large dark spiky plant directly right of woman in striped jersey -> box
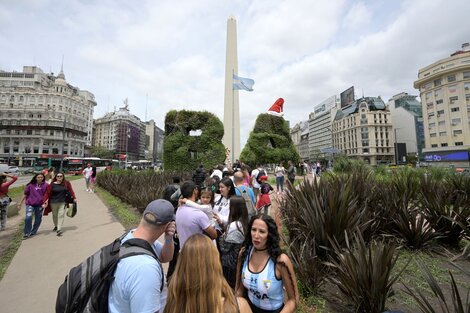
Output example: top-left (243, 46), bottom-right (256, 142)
top-left (280, 175), bottom-right (370, 289)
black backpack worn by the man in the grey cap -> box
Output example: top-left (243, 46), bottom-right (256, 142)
top-left (55, 234), bottom-right (164, 313)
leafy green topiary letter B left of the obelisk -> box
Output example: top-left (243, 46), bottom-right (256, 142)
top-left (163, 110), bottom-right (225, 171)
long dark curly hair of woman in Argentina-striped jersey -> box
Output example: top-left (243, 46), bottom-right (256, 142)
top-left (241, 214), bottom-right (282, 268)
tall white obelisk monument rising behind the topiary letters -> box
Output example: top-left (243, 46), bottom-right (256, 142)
top-left (222, 17), bottom-right (240, 164)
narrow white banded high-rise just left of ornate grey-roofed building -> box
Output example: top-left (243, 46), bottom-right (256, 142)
top-left (308, 96), bottom-right (339, 161)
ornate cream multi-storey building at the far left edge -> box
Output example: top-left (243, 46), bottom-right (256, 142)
top-left (0, 66), bottom-right (96, 166)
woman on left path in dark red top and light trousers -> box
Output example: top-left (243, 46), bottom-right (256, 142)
top-left (42, 172), bottom-right (77, 237)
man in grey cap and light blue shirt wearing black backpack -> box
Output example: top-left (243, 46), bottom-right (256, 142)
top-left (55, 199), bottom-right (176, 313)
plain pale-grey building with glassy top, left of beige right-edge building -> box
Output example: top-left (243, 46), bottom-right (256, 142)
top-left (387, 92), bottom-right (425, 159)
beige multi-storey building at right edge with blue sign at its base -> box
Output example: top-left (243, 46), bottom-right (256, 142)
top-left (414, 43), bottom-right (470, 167)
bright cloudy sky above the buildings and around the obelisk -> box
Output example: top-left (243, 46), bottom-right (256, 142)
top-left (0, 0), bottom-right (470, 147)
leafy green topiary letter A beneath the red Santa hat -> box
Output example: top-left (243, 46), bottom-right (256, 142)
top-left (240, 113), bottom-right (300, 166)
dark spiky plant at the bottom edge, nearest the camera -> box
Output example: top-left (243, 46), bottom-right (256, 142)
top-left (328, 232), bottom-right (405, 313)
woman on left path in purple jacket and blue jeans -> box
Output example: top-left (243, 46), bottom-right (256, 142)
top-left (18, 173), bottom-right (49, 239)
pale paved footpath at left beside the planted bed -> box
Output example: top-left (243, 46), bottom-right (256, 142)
top-left (0, 179), bottom-right (130, 313)
